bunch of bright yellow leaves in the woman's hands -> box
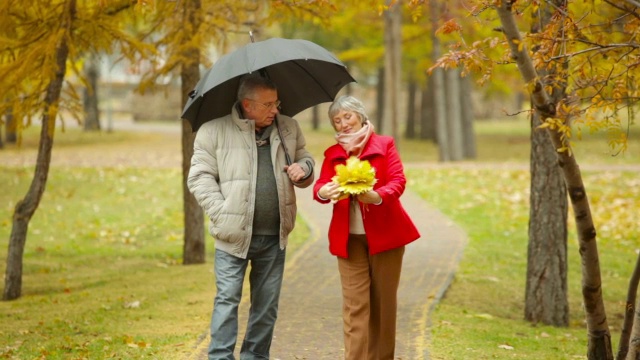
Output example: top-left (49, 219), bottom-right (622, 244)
top-left (331, 156), bottom-right (378, 195)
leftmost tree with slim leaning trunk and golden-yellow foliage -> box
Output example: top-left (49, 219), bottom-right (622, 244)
top-left (0, 0), bottom-right (151, 300)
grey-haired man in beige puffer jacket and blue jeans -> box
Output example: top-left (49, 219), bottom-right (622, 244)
top-left (187, 74), bottom-right (314, 360)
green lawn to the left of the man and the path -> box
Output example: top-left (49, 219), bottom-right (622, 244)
top-left (0, 168), bottom-right (309, 359)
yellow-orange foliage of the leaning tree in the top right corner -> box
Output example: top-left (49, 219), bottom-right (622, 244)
top-left (429, 0), bottom-right (640, 151)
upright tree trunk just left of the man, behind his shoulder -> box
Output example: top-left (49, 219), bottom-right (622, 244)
top-left (180, 0), bottom-right (206, 265)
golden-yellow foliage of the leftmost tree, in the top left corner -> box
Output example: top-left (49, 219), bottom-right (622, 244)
top-left (0, 0), bottom-right (154, 135)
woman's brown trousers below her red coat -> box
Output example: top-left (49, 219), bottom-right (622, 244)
top-left (338, 234), bottom-right (404, 360)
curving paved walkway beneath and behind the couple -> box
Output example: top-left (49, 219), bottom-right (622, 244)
top-left (190, 174), bottom-right (467, 360)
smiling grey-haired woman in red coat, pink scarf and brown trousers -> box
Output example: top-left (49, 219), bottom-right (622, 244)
top-left (314, 96), bottom-right (420, 360)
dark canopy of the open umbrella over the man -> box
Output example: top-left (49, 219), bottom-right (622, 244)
top-left (182, 38), bottom-right (355, 131)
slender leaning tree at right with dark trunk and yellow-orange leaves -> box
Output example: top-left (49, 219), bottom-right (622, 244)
top-left (424, 0), bottom-right (640, 359)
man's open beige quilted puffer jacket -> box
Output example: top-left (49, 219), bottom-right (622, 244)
top-left (187, 106), bottom-right (314, 258)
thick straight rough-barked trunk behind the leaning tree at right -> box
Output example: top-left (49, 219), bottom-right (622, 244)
top-left (524, 0), bottom-right (569, 326)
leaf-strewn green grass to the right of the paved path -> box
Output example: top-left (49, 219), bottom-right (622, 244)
top-left (408, 168), bottom-right (640, 360)
